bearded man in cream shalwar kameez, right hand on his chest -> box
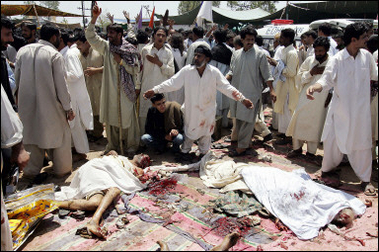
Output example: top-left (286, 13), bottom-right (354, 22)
top-left (286, 37), bottom-right (330, 159)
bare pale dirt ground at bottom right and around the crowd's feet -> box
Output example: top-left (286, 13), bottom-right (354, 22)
top-left (15, 110), bottom-right (378, 251)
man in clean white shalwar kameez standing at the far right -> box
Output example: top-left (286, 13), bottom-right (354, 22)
top-left (307, 23), bottom-right (378, 195)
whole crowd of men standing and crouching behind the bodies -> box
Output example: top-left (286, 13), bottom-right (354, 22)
top-left (1, 1), bottom-right (378, 249)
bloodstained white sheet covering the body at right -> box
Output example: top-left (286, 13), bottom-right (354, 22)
top-left (241, 165), bottom-right (366, 240)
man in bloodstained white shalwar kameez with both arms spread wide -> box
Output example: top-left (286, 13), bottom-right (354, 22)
top-left (144, 45), bottom-right (253, 155)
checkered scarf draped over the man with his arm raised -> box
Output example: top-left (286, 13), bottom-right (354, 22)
top-left (110, 38), bottom-right (142, 103)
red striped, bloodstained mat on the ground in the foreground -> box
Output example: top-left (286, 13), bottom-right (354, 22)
top-left (21, 173), bottom-right (281, 251)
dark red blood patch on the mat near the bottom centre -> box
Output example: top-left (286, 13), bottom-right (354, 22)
top-left (214, 217), bottom-right (250, 236)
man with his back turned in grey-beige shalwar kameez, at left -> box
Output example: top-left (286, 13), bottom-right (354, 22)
top-left (15, 24), bottom-right (75, 179)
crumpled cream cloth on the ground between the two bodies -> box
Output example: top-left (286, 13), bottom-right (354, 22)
top-left (150, 151), bottom-right (250, 193)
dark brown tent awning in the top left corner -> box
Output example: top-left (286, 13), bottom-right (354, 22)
top-left (1, 4), bottom-right (82, 17)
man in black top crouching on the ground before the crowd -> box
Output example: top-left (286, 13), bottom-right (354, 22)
top-left (141, 94), bottom-right (184, 154)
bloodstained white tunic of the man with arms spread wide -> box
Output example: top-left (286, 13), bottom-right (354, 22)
top-left (153, 64), bottom-right (242, 140)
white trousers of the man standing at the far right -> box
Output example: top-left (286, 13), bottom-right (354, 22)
top-left (321, 127), bottom-right (372, 182)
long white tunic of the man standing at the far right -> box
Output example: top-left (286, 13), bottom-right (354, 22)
top-left (318, 48), bottom-right (378, 154)
